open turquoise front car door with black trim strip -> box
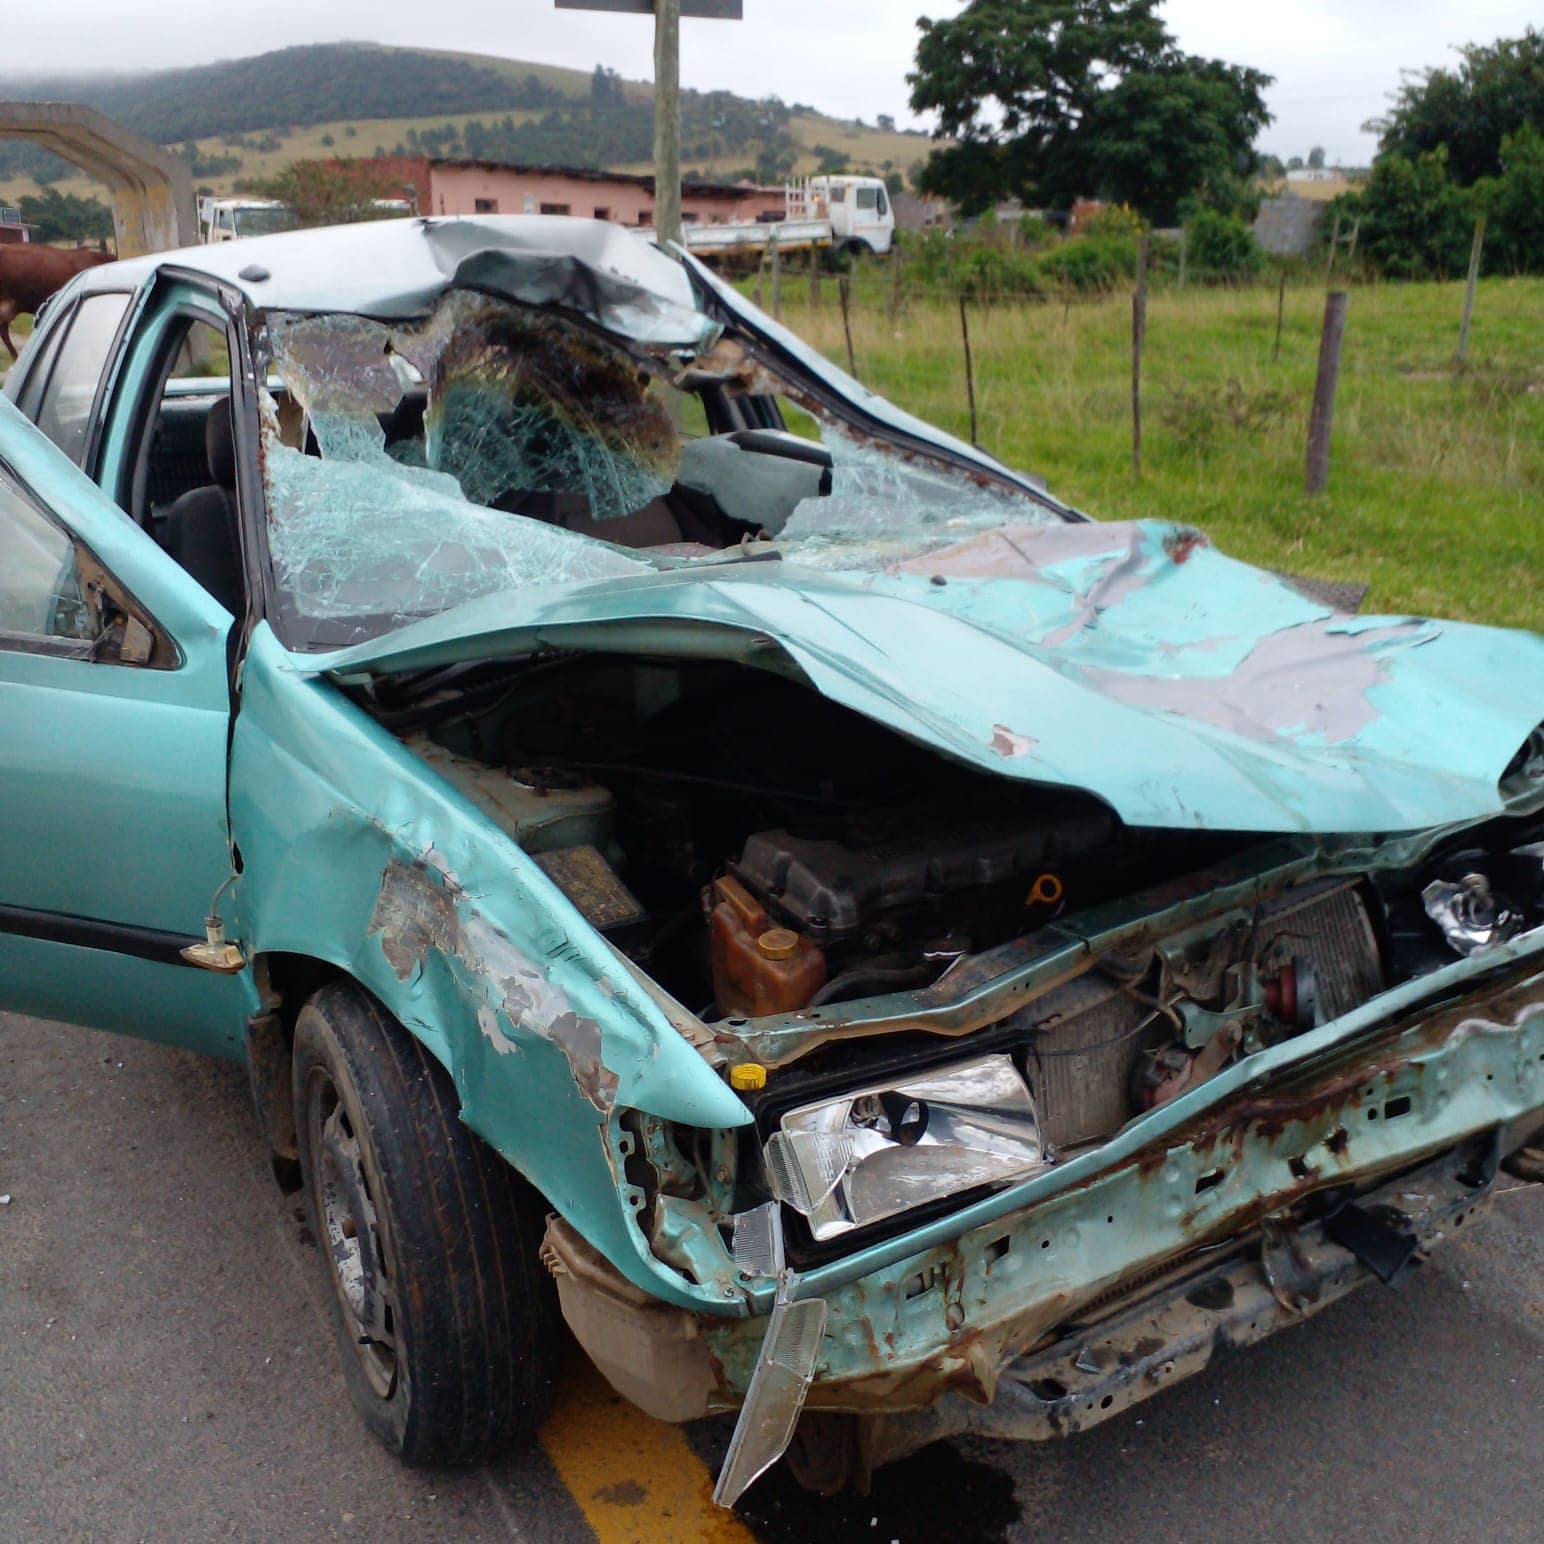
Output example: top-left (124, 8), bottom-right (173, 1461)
top-left (0, 392), bottom-right (253, 1056)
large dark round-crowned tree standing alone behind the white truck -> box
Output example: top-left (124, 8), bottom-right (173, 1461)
top-left (906, 0), bottom-right (1271, 218)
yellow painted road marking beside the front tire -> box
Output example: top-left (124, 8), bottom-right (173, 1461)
top-left (542, 1353), bottom-right (755, 1544)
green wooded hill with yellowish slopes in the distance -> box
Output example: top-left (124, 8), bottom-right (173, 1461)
top-left (0, 43), bottom-right (928, 199)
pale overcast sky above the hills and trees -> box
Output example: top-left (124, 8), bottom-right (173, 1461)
top-left (15, 0), bottom-right (1539, 164)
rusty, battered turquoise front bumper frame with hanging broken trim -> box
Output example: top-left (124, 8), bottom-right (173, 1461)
top-left (548, 933), bottom-right (1544, 1504)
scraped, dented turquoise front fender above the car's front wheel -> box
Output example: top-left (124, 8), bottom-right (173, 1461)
top-left (230, 625), bottom-right (750, 1312)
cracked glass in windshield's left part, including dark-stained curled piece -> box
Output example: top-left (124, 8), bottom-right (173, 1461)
top-left (262, 293), bottom-right (679, 641)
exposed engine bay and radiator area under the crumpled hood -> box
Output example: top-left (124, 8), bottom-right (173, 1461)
top-left (371, 658), bottom-right (1544, 1152)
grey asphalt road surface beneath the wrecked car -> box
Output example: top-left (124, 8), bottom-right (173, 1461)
top-left (0, 1016), bottom-right (1544, 1544)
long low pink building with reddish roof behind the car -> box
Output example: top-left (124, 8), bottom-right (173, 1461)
top-left (325, 156), bottom-right (784, 225)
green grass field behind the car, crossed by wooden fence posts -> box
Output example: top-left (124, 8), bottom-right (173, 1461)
top-left (772, 276), bottom-right (1544, 631)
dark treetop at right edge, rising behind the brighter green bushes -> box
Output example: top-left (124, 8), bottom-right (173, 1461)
top-left (1368, 28), bottom-right (1544, 187)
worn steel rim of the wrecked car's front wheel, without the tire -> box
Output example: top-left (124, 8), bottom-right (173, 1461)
top-left (306, 1067), bottom-right (397, 1399)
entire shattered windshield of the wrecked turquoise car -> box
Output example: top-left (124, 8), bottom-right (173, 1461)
top-left (261, 289), bottom-right (1056, 648)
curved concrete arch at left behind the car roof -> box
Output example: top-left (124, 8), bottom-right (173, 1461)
top-left (0, 102), bottom-right (198, 258)
